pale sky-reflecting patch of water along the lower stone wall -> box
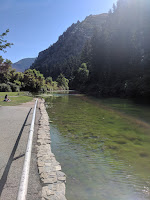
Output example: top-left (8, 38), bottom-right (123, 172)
top-left (51, 126), bottom-right (149, 200)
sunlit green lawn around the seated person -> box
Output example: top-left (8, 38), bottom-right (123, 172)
top-left (0, 92), bottom-right (33, 106)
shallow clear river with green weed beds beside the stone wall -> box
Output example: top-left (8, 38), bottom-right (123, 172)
top-left (45, 93), bottom-right (150, 200)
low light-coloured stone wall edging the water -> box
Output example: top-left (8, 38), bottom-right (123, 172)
top-left (37, 100), bottom-right (66, 200)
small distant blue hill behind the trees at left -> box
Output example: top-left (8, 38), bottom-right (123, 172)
top-left (12, 58), bottom-right (35, 72)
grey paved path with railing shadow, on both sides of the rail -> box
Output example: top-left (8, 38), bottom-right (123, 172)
top-left (0, 101), bottom-right (41, 200)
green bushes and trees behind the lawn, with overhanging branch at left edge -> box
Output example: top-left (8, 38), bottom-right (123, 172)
top-left (0, 29), bottom-right (69, 92)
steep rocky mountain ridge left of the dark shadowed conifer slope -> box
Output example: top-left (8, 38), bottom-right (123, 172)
top-left (31, 13), bottom-right (108, 79)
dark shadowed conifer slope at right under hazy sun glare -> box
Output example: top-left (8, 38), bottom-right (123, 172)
top-left (78, 0), bottom-right (150, 97)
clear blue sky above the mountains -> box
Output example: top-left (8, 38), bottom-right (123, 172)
top-left (0, 0), bottom-right (117, 63)
